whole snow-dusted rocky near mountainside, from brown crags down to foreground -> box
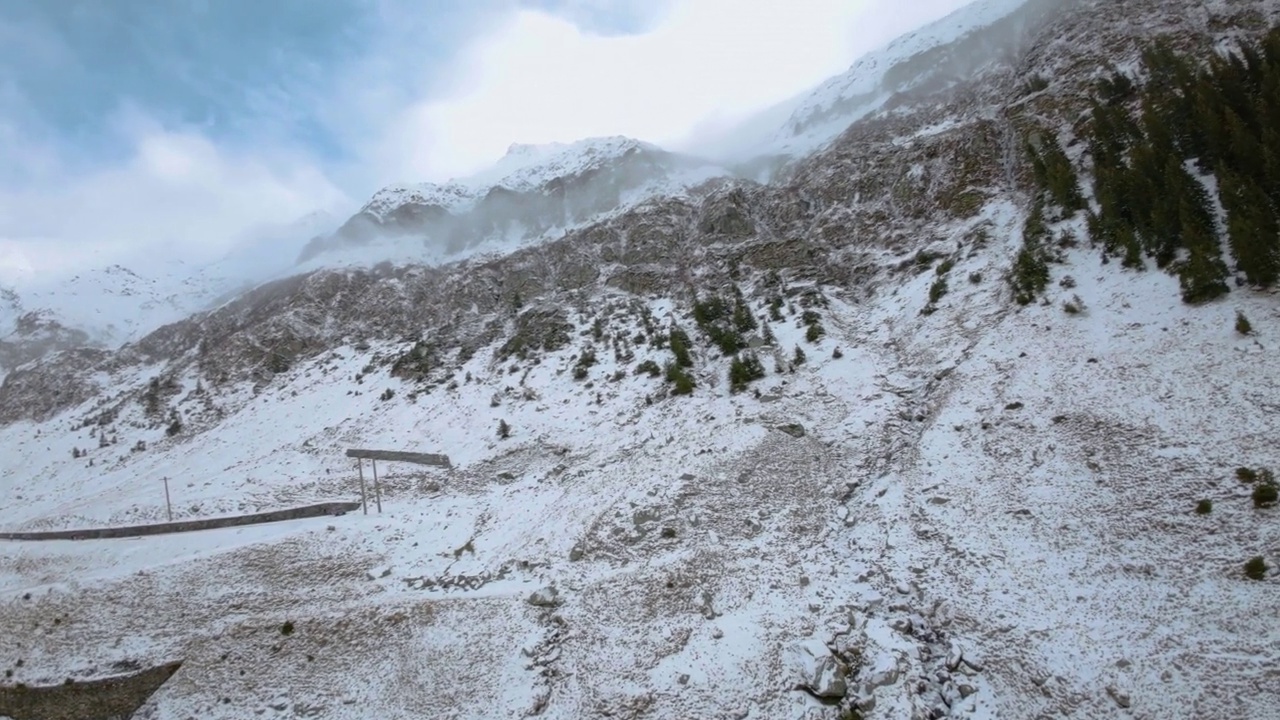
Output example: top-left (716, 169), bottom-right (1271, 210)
top-left (0, 0), bottom-right (1280, 719)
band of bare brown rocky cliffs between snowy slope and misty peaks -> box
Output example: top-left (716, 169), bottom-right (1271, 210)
top-left (10, 0), bottom-right (1280, 430)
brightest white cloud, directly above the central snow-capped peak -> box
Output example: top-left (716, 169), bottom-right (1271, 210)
top-left (371, 0), bottom-right (964, 181)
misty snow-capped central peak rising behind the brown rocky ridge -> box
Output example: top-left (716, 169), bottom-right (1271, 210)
top-left (293, 137), bottom-right (731, 268)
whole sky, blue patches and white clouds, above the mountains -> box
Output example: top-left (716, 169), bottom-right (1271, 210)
top-left (0, 0), bottom-right (965, 283)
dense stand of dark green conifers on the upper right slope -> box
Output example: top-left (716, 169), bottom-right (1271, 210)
top-left (1014, 28), bottom-right (1280, 304)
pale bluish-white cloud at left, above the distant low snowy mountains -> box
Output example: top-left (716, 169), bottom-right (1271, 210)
top-left (0, 114), bottom-right (346, 283)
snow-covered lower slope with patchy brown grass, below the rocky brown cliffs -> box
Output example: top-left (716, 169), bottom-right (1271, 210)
top-left (0, 197), bottom-right (1280, 719)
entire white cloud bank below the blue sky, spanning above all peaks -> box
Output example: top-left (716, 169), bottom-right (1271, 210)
top-left (0, 0), bottom-right (964, 282)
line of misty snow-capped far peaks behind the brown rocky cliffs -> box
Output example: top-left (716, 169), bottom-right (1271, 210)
top-left (0, 0), bottom-right (1075, 370)
